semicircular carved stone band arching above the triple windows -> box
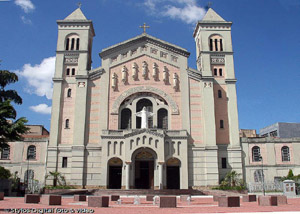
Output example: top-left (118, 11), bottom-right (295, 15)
top-left (111, 86), bottom-right (179, 114)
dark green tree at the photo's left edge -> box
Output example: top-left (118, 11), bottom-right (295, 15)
top-left (0, 70), bottom-right (28, 149)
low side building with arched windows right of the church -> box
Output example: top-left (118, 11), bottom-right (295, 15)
top-left (241, 137), bottom-right (300, 184)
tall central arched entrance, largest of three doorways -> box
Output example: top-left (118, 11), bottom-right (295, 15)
top-left (133, 148), bottom-right (156, 189)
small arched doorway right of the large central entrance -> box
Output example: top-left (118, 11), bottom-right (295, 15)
top-left (167, 158), bottom-right (180, 189)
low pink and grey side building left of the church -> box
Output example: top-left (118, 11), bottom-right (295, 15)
top-left (0, 125), bottom-right (49, 184)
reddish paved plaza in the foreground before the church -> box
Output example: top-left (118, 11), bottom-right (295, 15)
top-left (0, 196), bottom-right (300, 214)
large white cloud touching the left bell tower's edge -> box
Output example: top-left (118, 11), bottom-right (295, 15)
top-left (16, 57), bottom-right (55, 99)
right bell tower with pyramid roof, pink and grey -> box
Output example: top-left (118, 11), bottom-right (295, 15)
top-left (193, 8), bottom-right (242, 180)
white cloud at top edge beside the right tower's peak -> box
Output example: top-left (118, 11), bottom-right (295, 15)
top-left (144, 0), bottom-right (206, 24)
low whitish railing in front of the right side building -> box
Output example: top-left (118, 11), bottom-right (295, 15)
top-left (247, 182), bottom-right (283, 192)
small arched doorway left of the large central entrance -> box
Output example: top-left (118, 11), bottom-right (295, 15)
top-left (108, 158), bottom-right (123, 189)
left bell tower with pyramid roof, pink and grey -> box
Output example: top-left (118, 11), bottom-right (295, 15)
top-left (47, 8), bottom-right (95, 186)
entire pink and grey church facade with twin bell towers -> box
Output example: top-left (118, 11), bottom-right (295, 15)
top-left (47, 8), bottom-right (242, 189)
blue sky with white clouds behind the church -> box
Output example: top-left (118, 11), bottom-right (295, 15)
top-left (0, 0), bottom-right (300, 130)
